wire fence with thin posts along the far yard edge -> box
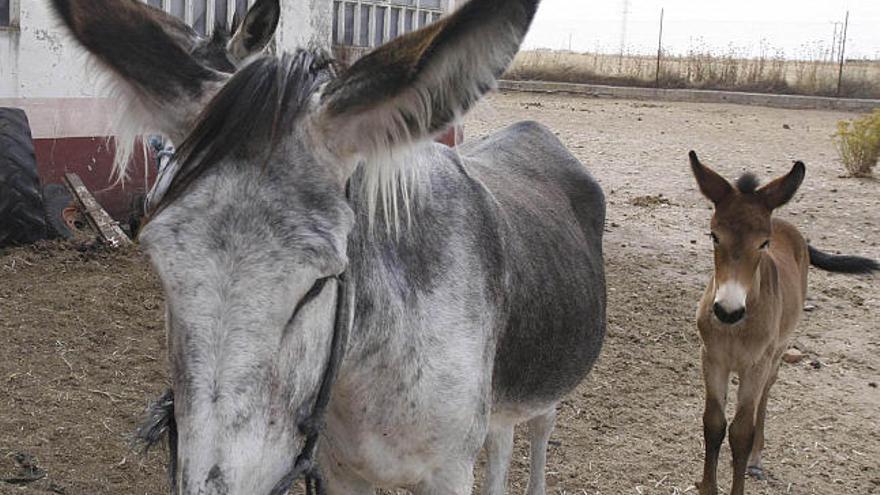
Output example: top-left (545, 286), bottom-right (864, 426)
top-left (507, 9), bottom-right (880, 98)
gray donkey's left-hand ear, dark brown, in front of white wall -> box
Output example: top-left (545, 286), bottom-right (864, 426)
top-left (52, 0), bottom-right (222, 135)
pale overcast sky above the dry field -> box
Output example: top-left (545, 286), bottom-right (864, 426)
top-left (525, 0), bottom-right (880, 59)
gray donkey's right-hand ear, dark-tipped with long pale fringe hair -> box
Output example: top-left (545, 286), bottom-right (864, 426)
top-left (316, 0), bottom-right (538, 156)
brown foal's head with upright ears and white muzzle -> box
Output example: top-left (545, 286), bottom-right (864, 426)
top-left (690, 151), bottom-right (805, 325)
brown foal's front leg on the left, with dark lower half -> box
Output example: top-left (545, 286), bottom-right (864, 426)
top-left (697, 351), bottom-right (730, 495)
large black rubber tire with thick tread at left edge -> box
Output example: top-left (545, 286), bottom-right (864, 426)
top-left (0, 108), bottom-right (47, 247)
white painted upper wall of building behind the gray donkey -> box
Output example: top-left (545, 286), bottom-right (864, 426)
top-left (0, 0), bottom-right (333, 99)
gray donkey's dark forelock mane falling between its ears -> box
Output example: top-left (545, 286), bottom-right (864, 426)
top-left (152, 50), bottom-right (335, 214)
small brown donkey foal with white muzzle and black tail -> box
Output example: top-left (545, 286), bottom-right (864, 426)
top-left (690, 151), bottom-right (880, 495)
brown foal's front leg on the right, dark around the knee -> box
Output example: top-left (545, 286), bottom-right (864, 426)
top-left (730, 364), bottom-right (770, 495)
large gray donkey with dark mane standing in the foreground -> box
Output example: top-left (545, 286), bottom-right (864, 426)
top-left (52, 0), bottom-right (605, 495)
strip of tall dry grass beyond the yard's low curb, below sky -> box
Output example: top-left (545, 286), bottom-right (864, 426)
top-left (505, 48), bottom-right (880, 98)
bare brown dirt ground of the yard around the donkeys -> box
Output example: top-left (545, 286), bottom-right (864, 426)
top-left (0, 94), bottom-right (880, 495)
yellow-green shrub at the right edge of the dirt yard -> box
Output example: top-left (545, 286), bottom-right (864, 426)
top-left (834, 108), bottom-right (880, 177)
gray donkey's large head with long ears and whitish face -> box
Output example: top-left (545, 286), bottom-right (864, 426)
top-left (53, 0), bottom-right (537, 495)
